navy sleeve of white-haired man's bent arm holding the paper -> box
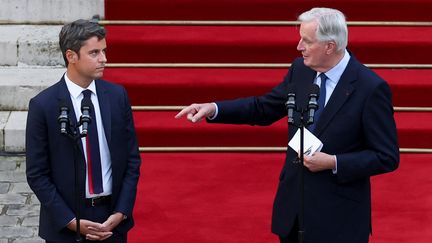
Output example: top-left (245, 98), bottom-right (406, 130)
top-left (337, 82), bottom-right (399, 183)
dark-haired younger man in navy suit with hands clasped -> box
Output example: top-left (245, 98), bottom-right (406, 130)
top-left (26, 20), bottom-right (141, 243)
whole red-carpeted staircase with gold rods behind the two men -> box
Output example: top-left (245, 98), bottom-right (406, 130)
top-left (101, 0), bottom-right (432, 243)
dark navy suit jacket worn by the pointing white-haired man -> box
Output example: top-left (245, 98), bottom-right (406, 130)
top-left (209, 56), bottom-right (399, 243)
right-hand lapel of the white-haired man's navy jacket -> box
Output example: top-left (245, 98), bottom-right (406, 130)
top-left (315, 56), bottom-right (359, 135)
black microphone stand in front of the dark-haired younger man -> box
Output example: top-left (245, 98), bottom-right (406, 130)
top-left (59, 118), bottom-right (87, 243)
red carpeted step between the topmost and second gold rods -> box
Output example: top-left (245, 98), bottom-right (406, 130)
top-left (106, 25), bottom-right (432, 63)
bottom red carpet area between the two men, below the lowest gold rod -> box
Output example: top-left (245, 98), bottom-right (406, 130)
top-left (129, 153), bottom-right (283, 243)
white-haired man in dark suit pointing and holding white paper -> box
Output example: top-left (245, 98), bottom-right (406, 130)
top-left (176, 8), bottom-right (399, 243)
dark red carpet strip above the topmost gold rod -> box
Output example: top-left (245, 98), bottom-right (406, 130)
top-left (105, 0), bottom-right (432, 21)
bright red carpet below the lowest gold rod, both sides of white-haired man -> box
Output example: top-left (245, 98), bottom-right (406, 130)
top-left (129, 153), bottom-right (432, 243)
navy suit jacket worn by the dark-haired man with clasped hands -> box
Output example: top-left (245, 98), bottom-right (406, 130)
top-left (26, 78), bottom-right (141, 242)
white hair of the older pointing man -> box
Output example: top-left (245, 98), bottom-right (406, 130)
top-left (298, 8), bottom-right (348, 51)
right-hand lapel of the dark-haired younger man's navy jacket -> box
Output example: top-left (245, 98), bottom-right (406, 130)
top-left (95, 80), bottom-right (111, 144)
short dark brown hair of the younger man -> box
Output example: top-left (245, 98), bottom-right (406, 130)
top-left (59, 19), bottom-right (106, 67)
